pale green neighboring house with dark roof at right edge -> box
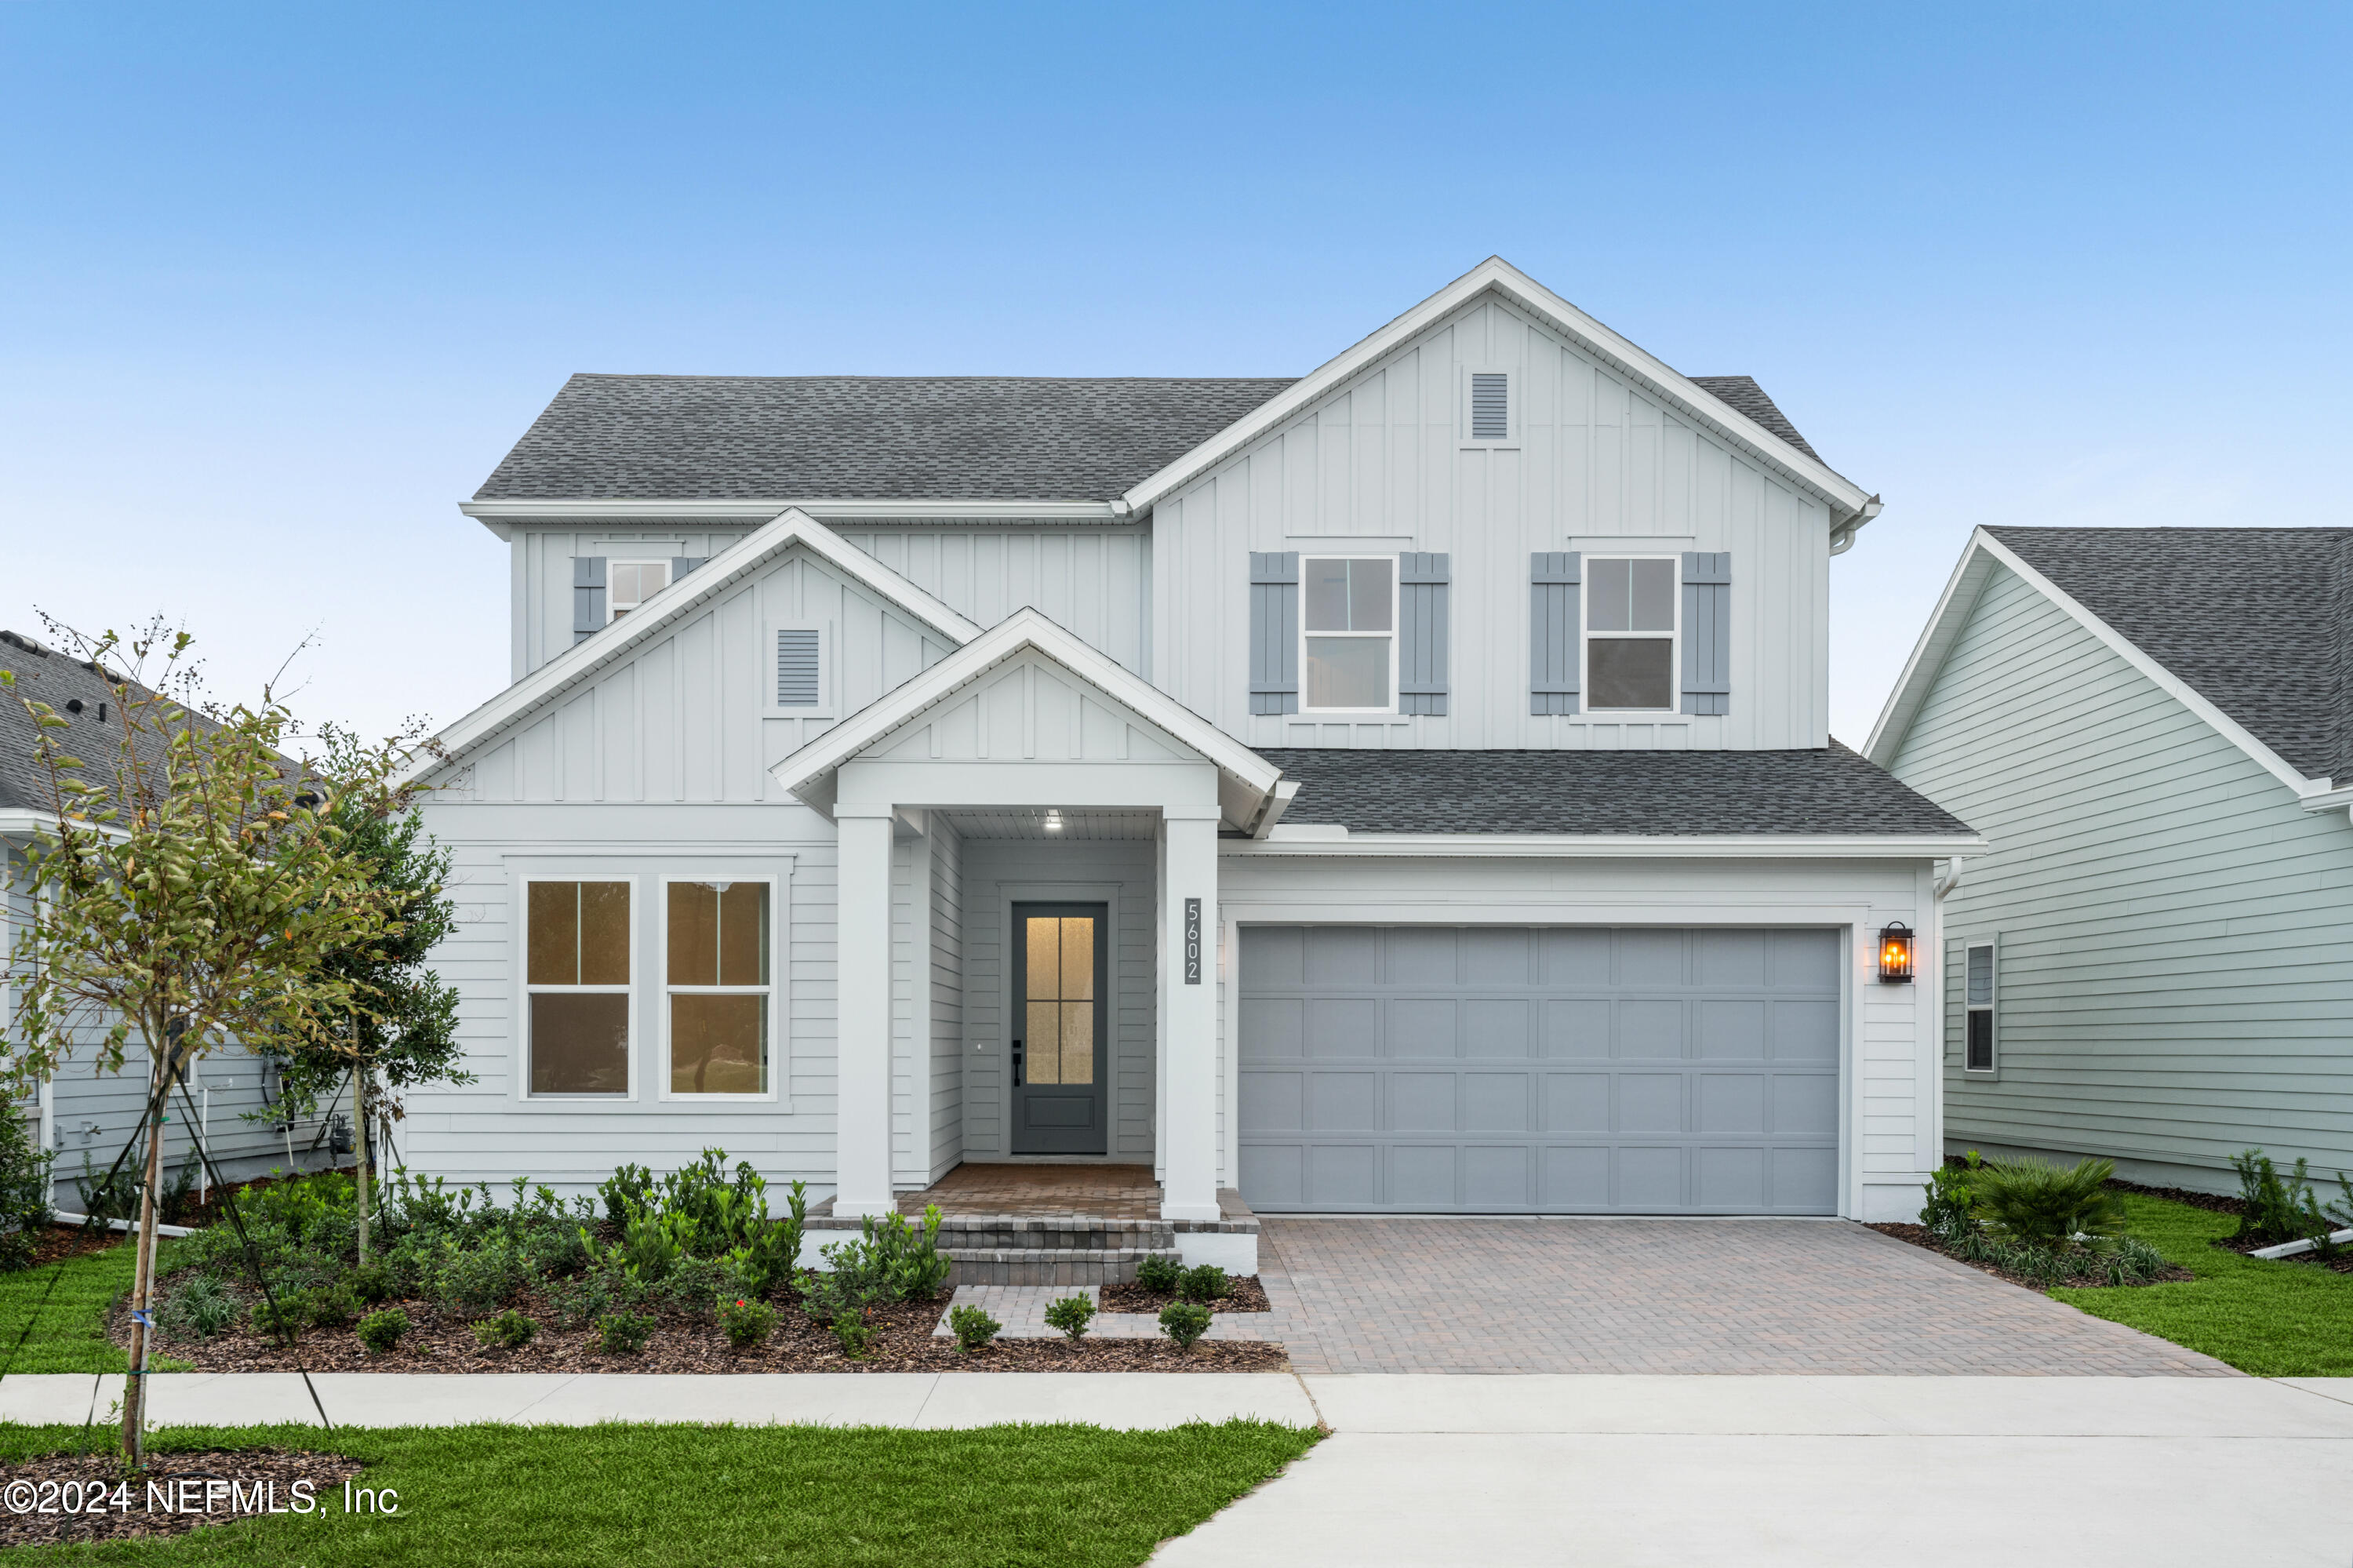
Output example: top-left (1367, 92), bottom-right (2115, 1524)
top-left (1868, 527), bottom-right (2353, 1191)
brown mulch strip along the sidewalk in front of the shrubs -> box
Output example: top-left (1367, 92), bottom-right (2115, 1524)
top-left (124, 1295), bottom-right (1289, 1373)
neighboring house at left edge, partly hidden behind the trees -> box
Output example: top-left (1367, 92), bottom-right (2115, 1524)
top-left (0, 631), bottom-right (329, 1210)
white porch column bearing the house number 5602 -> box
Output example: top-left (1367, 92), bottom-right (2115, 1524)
top-left (1160, 806), bottom-right (1217, 1220)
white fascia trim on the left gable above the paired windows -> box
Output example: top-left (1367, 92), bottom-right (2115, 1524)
top-left (400, 511), bottom-right (981, 784)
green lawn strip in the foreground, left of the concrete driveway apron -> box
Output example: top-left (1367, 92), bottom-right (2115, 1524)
top-left (0, 1422), bottom-right (1315, 1568)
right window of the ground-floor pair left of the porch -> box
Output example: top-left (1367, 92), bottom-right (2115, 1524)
top-left (664, 879), bottom-right (776, 1097)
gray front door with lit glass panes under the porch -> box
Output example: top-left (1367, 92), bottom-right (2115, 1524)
top-left (1012, 904), bottom-right (1111, 1154)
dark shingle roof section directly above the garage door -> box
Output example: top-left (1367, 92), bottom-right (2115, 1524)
top-left (1257, 741), bottom-right (1969, 836)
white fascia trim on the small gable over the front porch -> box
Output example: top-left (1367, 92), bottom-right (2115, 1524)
top-left (767, 609), bottom-right (1282, 810)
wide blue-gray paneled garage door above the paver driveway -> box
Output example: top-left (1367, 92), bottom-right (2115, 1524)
top-left (1240, 926), bottom-right (1838, 1215)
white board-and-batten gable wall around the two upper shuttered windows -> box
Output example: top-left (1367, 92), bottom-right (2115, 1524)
top-left (1151, 297), bottom-right (1828, 751)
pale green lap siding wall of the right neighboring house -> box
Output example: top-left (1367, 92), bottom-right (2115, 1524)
top-left (1892, 567), bottom-right (2353, 1191)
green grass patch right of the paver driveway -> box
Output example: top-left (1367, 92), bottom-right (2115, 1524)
top-left (2052, 1194), bottom-right (2353, 1377)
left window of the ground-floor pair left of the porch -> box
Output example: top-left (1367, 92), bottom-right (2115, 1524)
top-left (522, 881), bottom-right (633, 1095)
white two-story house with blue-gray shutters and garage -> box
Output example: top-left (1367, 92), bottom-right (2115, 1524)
top-left (407, 250), bottom-right (1981, 1224)
